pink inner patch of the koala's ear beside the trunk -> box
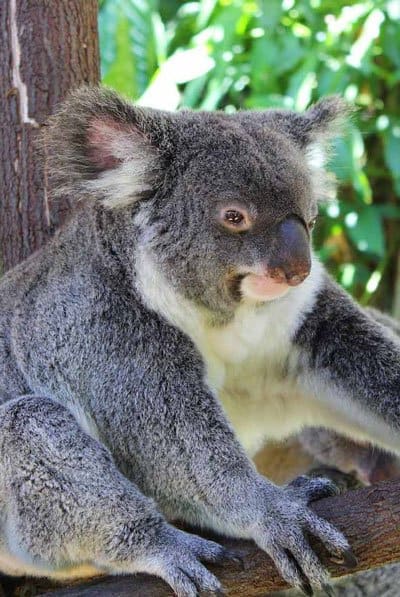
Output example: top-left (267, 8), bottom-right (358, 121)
top-left (87, 118), bottom-right (132, 170)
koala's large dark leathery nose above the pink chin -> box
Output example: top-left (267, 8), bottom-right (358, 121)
top-left (268, 216), bottom-right (311, 286)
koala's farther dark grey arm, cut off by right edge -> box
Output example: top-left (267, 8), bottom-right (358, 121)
top-left (294, 276), bottom-right (400, 452)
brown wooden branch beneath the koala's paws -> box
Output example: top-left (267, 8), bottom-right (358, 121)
top-left (41, 479), bottom-right (400, 597)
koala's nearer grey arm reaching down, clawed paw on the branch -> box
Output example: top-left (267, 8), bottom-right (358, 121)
top-left (82, 317), bottom-right (354, 587)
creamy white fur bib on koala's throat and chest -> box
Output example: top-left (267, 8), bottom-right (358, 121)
top-left (137, 254), bottom-right (342, 454)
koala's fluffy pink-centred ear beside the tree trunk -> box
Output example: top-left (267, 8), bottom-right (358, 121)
top-left (45, 87), bottom-right (167, 207)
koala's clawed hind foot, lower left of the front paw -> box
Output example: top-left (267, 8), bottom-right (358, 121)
top-left (141, 527), bottom-right (238, 597)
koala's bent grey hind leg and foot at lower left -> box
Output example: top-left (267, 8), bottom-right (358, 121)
top-left (0, 396), bottom-right (232, 597)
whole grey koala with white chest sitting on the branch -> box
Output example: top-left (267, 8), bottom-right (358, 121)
top-left (0, 88), bottom-right (400, 597)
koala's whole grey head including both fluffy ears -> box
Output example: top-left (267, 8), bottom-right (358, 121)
top-left (46, 89), bottom-right (348, 312)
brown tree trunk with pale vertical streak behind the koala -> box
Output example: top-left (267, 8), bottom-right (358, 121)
top-left (0, 0), bottom-right (99, 273)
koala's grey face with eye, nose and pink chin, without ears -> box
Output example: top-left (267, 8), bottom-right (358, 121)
top-left (147, 114), bottom-right (317, 309)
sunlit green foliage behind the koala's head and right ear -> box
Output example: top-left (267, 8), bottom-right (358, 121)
top-left (100, 0), bottom-right (400, 309)
